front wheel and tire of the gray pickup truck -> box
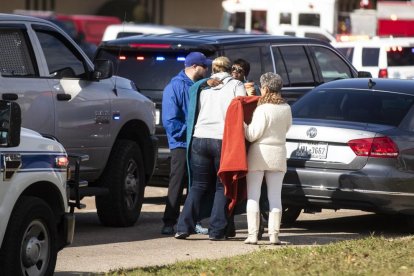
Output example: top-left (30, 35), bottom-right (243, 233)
top-left (95, 140), bottom-right (145, 227)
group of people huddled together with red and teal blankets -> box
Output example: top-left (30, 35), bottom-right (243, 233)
top-left (161, 52), bottom-right (292, 244)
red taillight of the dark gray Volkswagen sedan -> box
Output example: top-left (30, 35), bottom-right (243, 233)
top-left (348, 137), bottom-right (398, 158)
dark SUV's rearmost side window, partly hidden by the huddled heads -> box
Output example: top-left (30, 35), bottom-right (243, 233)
top-left (224, 47), bottom-right (262, 83)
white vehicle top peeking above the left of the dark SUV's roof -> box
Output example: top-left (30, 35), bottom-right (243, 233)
top-left (102, 23), bottom-right (188, 41)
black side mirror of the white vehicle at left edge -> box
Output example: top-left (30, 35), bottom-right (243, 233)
top-left (0, 101), bottom-right (22, 147)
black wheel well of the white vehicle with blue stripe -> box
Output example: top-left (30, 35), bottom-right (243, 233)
top-left (23, 181), bottom-right (66, 218)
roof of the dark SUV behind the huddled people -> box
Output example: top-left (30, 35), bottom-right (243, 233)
top-left (100, 32), bottom-right (330, 49)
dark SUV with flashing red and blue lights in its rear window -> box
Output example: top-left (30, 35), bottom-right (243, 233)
top-left (95, 32), bottom-right (368, 185)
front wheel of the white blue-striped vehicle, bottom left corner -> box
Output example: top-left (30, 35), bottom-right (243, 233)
top-left (0, 196), bottom-right (58, 276)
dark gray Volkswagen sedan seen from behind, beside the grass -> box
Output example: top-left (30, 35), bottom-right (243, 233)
top-left (282, 79), bottom-right (414, 226)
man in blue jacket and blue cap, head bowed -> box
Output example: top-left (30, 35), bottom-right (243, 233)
top-left (161, 52), bottom-right (211, 235)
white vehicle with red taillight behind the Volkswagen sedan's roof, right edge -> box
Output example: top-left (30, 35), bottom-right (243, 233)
top-left (332, 38), bottom-right (414, 79)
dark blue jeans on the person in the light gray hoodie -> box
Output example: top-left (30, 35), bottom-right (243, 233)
top-left (177, 138), bottom-right (227, 237)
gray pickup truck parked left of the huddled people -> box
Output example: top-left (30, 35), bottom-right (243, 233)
top-left (0, 14), bottom-right (157, 227)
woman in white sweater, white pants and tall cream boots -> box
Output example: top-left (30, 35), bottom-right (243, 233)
top-left (244, 72), bottom-right (292, 244)
